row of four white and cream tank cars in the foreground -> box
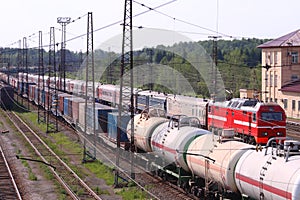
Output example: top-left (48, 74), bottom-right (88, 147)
top-left (127, 109), bottom-right (300, 200)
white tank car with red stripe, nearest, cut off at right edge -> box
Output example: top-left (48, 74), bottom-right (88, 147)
top-left (235, 141), bottom-right (300, 200)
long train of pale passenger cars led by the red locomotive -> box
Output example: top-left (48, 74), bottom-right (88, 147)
top-left (0, 73), bottom-right (286, 144)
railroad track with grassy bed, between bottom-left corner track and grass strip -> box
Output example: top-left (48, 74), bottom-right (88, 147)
top-left (4, 111), bottom-right (101, 200)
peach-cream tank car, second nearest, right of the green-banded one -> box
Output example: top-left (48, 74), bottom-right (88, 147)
top-left (186, 135), bottom-right (254, 192)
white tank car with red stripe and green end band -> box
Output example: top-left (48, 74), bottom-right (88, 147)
top-left (151, 116), bottom-right (211, 171)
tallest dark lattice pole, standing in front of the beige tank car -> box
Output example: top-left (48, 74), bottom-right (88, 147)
top-left (115, 0), bottom-right (135, 186)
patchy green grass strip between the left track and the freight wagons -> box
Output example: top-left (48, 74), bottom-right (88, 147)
top-left (13, 102), bottom-right (147, 200)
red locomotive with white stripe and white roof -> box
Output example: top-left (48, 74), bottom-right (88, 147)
top-left (207, 99), bottom-right (286, 144)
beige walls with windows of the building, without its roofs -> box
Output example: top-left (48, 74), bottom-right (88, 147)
top-left (261, 47), bottom-right (300, 118)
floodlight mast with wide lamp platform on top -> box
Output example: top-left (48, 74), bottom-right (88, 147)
top-left (57, 17), bottom-right (71, 92)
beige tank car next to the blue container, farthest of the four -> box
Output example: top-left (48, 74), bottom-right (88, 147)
top-left (127, 109), bottom-right (167, 152)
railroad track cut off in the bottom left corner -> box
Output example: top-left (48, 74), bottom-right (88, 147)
top-left (0, 142), bottom-right (22, 200)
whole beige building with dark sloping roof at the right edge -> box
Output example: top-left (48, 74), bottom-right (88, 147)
top-left (258, 29), bottom-right (300, 119)
